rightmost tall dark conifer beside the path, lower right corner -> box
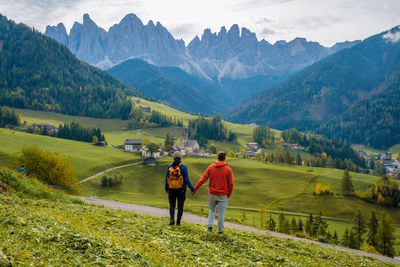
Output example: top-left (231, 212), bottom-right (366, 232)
top-left (376, 214), bottom-right (395, 257)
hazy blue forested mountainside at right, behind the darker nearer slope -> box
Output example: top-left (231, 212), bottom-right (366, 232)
top-left (230, 27), bottom-right (400, 147)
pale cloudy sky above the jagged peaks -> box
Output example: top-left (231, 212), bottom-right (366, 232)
top-left (0, 0), bottom-right (400, 46)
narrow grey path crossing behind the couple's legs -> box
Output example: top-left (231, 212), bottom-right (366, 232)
top-left (81, 197), bottom-right (400, 265)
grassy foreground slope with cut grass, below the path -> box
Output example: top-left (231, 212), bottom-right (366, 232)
top-left (0, 173), bottom-right (389, 266)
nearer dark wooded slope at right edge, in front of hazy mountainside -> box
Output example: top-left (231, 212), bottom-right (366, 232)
top-left (317, 72), bottom-right (400, 149)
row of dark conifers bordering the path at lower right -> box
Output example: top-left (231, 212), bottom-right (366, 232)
top-left (255, 209), bottom-right (396, 257)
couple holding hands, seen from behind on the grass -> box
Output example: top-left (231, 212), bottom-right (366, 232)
top-left (165, 152), bottom-right (233, 234)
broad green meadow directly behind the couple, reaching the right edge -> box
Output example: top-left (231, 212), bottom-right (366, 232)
top-left (82, 157), bottom-right (400, 223)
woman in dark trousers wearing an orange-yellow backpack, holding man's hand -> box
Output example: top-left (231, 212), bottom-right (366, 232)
top-left (165, 151), bottom-right (195, 225)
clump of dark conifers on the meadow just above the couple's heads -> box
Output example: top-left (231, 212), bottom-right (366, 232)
top-left (188, 113), bottom-right (237, 146)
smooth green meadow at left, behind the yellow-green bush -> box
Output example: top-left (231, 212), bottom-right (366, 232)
top-left (0, 128), bottom-right (140, 179)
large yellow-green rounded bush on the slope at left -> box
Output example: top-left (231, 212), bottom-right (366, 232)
top-left (10, 146), bottom-right (79, 191)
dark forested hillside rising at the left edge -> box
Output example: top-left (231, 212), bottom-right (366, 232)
top-left (0, 15), bottom-right (138, 119)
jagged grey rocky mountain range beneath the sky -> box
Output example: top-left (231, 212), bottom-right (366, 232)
top-left (45, 14), bottom-right (360, 79)
